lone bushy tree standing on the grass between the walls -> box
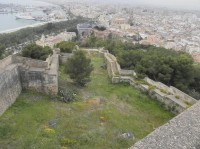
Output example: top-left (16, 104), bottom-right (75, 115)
top-left (65, 50), bottom-right (93, 86)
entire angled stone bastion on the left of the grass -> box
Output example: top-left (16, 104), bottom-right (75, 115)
top-left (0, 49), bottom-right (60, 115)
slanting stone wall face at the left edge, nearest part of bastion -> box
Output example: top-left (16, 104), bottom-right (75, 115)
top-left (0, 63), bottom-right (22, 115)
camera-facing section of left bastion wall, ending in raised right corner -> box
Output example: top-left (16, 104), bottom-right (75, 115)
top-left (18, 50), bottom-right (59, 94)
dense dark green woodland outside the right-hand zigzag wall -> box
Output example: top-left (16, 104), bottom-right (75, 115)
top-left (82, 36), bottom-right (200, 99)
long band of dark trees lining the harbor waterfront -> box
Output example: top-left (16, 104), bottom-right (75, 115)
top-left (0, 17), bottom-right (88, 47)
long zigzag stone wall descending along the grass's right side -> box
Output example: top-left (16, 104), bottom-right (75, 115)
top-left (93, 49), bottom-right (197, 114)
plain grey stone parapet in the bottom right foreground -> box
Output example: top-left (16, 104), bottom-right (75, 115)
top-left (129, 101), bottom-right (200, 149)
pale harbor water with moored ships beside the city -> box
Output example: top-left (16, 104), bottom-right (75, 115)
top-left (0, 0), bottom-right (68, 33)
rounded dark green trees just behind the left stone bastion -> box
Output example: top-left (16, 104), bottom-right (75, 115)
top-left (22, 44), bottom-right (52, 60)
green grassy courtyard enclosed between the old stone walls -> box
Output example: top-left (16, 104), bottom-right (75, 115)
top-left (0, 57), bottom-right (173, 149)
